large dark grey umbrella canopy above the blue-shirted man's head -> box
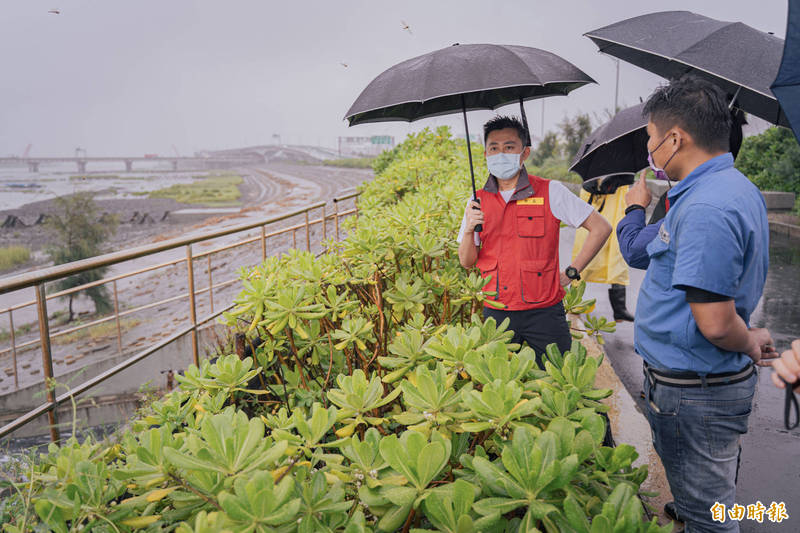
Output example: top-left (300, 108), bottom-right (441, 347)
top-left (584, 11), bottom-right (789, 127)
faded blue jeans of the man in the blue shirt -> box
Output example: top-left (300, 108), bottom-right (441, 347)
top-left (644, 372), bottom-right (758, 533)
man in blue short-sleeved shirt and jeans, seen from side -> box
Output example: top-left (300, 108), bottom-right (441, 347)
top-left (634, 76), bottom-right (774, 532)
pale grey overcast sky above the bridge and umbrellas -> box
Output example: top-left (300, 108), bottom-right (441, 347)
top-left (0, 0), bottom-right (787, 156)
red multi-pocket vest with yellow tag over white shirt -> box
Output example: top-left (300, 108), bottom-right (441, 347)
top-left (475, 172), bottom-right (564, 311)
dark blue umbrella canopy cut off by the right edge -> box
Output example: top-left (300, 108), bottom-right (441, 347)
top-left (772, 0), bottom-right (800, 142)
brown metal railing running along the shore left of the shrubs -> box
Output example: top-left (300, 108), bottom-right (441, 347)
top-left (0, 191), bottom-right (360, 441)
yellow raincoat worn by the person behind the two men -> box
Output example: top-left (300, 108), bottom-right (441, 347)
top-left (572, 185), bottom-right (630, 285)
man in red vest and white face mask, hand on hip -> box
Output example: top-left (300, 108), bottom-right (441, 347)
top-left (458, 117), bottom-right (611, 366)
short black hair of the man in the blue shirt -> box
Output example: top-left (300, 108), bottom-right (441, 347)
top-left (642, 75), bottom-right (732, 152)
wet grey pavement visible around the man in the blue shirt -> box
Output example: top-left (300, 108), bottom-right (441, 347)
top-left (561, 228), bottom-right (800, 533)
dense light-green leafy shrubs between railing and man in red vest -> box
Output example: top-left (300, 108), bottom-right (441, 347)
top-left (0, 129), bottom-right (670, 533)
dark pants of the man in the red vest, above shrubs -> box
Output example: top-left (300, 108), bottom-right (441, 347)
top-left (483, 302), bottom-right (572, 368)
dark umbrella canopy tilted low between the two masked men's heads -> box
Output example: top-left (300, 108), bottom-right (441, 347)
top-left (569, 103), bottom-right (647, 183)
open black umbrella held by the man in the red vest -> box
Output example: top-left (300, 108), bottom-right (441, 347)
top-left (345, 44), bottom-right (594, 210)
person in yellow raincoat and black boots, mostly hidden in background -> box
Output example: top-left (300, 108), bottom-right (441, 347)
top-left (572, 174), bottom-right (633, 322)
